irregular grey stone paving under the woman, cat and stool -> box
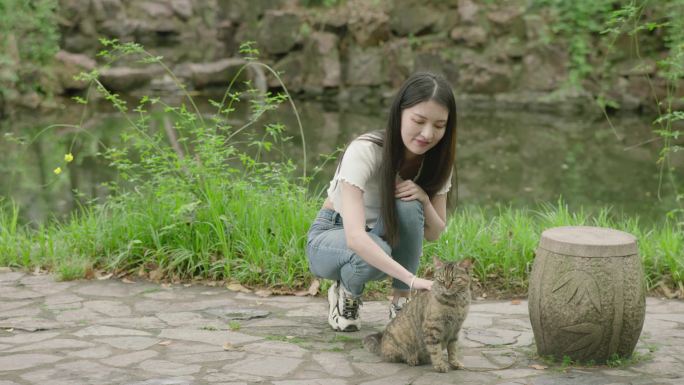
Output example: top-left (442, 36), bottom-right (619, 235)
top-left (0, 268), bottom-right (684, 385)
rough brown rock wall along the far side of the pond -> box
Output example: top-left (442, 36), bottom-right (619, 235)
top-left (12, 0), bottom-right (684, 113)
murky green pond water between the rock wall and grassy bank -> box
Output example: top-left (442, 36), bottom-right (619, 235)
top-left (0, 96), bottom-right (684, 223)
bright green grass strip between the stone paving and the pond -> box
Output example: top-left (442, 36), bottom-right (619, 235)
top-left (0, 195), bottom-right (684, 292)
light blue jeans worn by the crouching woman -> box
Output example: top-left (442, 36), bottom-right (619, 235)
top-left (306, 199), bottom-right (425, 297)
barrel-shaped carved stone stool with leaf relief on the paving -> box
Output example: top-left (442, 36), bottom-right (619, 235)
top-left (528, 226), bottom-right (646, 363)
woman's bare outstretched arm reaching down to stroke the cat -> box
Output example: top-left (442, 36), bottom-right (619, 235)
top-left (340, 180), bottom-right (432, 289)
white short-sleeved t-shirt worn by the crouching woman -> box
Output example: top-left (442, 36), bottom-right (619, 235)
top-left (328, 134), bottom-right (453, 228)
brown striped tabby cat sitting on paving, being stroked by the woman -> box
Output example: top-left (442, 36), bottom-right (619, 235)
top-left (363, 258), bottom-right (472, 373)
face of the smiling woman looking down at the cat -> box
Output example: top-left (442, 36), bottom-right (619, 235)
top-left (401, 100), bottom-right (449, 159)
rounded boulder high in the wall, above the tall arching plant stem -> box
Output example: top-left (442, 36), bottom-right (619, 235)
top-left (257, 10), bottom-right (302, 55)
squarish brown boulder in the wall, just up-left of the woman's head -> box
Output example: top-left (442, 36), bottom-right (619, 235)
top-left (344, 46), bottom-right (385, 86)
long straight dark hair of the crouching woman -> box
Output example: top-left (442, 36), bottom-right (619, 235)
top-left (380, 72), bottom-right (456, 246)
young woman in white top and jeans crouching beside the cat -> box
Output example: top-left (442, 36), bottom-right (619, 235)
top-left (307, 73), bottom-right (456, 331)
